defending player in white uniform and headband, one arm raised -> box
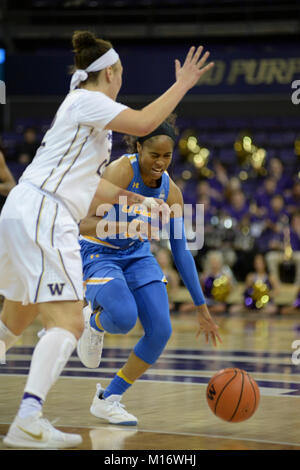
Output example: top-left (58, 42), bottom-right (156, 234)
top-left (0, 32), bottom-right (213, 448)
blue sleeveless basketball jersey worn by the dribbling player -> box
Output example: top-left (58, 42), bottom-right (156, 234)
top-left (80, 153), bottom-right (170, 250)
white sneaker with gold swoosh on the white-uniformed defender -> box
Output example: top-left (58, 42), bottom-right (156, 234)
top-left (3, 412), bottom-right (82, 449)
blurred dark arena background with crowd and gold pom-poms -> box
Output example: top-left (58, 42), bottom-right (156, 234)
top-left (0, 0), bottom-right (300, 315)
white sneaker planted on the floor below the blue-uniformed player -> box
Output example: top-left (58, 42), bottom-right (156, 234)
top-left (90, 384), bottom-right (138, 426)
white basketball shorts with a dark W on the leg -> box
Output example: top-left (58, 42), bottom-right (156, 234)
top-left (0, 183), bottom-right (83, 305)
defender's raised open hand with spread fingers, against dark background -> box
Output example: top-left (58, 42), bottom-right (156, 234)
top-left (175, 46), bottom-right (214, 89)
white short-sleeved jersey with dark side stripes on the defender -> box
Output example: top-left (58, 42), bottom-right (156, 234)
top-left (20, 89), bottom-right (127, 222)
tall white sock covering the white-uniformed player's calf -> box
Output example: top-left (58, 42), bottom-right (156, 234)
top-left (25, 328), bottom-right (77, 401)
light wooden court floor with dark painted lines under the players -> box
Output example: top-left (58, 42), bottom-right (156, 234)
top-left (0, 315), bottom-right (300, 450)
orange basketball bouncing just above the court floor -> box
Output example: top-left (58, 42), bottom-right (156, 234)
top-left (206, 369), bottom-right (260, 423)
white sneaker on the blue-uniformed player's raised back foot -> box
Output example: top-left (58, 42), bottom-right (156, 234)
top-left (77, 305), bottom-right (104, 369)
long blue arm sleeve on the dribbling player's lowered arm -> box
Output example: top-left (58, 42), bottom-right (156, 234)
top-left (170, 217), bottom-right (206, 305)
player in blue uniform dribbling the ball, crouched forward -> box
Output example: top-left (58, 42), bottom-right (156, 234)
top-left (77, 121), bottom-right (221, 425)
